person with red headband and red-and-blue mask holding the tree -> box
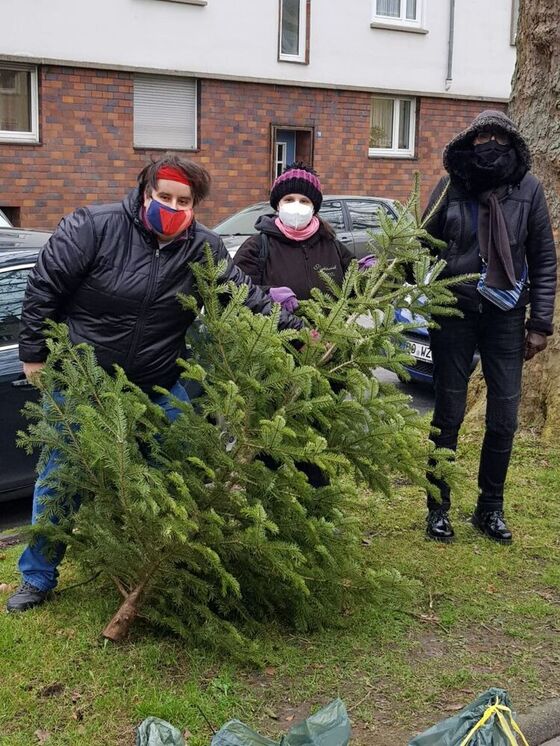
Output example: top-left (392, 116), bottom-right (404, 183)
top-left (8, 156), bottom-right (302, 611)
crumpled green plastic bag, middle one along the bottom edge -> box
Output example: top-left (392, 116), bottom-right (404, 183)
top-left (211, 699), bottom-right (351, 746)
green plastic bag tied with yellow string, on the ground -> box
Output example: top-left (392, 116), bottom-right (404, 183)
top-left (408, 688), bottom-right (529, 746)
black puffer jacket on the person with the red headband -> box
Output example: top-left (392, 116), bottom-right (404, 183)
top-left (19, 189), bottom-right (301, 391)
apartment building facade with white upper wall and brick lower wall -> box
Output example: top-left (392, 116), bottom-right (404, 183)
top-left (0, 0), bottom-right (516, 228)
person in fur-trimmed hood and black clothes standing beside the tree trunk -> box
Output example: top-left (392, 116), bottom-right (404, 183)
top-left (425, 110), bottom-right (556, 544)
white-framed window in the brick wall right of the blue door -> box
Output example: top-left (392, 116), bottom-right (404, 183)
top-left (369, 96), bottom-right (416, 158)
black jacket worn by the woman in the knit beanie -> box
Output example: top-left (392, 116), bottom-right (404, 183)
top-left (233, 215), bottom-right (354, 300)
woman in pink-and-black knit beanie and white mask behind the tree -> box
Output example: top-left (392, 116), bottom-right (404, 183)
top-left (234, 162), bottom-right (360, 487)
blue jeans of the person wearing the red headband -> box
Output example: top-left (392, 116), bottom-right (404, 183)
top-left (18, 381), bottom-right (190, 591)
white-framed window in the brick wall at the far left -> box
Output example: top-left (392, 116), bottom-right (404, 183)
top-left (0, 64), bottom-right (39, 142)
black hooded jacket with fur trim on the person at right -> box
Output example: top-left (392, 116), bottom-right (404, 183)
top-left (425, 112), bottom-right (556, 334)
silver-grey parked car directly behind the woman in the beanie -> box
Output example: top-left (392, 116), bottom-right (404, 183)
top-left (212, 194), bottom-right (397, 259)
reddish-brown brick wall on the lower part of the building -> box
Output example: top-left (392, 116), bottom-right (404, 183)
top-left (0, 66), bottom-right (504, 228)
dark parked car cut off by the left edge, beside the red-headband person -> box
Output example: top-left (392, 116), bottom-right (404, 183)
top-left (0, 228), bottom-right (50, 502)
